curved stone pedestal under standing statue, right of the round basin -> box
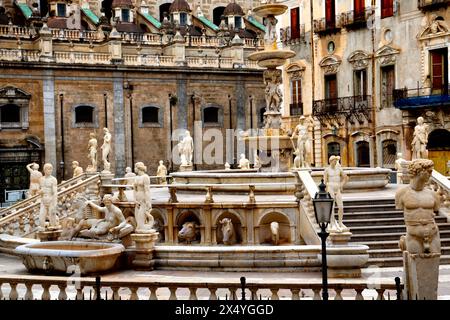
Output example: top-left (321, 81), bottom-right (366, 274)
top-left (131, 231), bottom-right (159, 270)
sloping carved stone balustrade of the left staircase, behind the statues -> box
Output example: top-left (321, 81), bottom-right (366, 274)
top-left (0, 174), bottom-right (100, 237)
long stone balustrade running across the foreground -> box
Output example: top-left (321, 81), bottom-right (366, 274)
top-left (0, 275), bottom-right (403, 300)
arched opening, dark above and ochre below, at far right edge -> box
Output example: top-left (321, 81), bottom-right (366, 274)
top-left (427, 129), bottom-right (450, 175)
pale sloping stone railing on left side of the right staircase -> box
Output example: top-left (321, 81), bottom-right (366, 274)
top-left (295, 170), bottom-right (321, 245)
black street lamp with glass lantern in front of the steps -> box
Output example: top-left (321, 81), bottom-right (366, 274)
top-left (312, 179), bottom-right (334, 300)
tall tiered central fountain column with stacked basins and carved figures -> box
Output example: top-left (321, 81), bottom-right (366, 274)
top-left (244, 0), bottom-right (295, 171)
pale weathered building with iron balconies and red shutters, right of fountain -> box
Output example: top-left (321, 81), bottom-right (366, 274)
top-left (281, 0), bottom-right (450, 174)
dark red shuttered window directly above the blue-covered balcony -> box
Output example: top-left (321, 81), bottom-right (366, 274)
top-left (430, 48), bottom-right (448, 94)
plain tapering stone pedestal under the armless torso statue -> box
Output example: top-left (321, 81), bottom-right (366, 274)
top-left (403, 251), bottom-right (441, 300)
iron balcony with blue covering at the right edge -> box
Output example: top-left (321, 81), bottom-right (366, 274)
top-left (393, 84), bottom-right (450, 110)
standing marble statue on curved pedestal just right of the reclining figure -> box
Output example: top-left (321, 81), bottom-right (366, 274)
top-left (133, 162), bottom-right (156, 233)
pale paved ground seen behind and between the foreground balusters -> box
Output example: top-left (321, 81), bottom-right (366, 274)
top-left (0, 254), bottom-right (450, 300)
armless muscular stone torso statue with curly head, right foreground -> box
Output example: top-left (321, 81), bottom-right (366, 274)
top-left (395, 159), bottom-right (441, 253)
